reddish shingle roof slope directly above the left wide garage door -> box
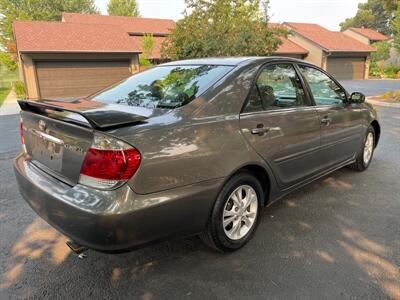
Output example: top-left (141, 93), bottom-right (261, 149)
top-left (13, 21), bottom-right (142, 53)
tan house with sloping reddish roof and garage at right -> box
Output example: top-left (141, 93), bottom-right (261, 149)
top-left (283, 22), bottom-right (375, 80)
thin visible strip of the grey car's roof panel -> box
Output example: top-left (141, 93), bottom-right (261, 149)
top-left (160, 56), bottom-right (304, 66)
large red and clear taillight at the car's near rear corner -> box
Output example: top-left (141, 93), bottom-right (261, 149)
top-left (79, 134), bottom-right (141, 189)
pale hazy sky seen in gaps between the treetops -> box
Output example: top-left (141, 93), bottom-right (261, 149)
top-left (95, 0), bottom-right (366, 30)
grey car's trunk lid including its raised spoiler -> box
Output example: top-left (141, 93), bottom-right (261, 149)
top-left (19, 100), bottom-right (151, 185)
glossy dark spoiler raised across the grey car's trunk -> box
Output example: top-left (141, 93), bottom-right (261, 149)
top-left (18, 100), bottom-right (147, 130)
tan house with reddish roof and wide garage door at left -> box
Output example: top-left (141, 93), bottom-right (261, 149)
top-left (13, 13), bottom-right (175, 99)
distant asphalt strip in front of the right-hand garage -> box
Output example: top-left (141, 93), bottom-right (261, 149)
top-left (341, 79), bottom-right (400, 97)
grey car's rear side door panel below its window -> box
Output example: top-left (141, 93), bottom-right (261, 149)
top-left (240, 106), bottom-right (321, 189)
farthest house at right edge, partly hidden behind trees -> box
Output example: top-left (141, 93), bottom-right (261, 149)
top-left (343, 27), bottom-right (400, 66)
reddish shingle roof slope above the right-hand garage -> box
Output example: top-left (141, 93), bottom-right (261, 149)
top-left (284, 22), bottom-right (375, 52)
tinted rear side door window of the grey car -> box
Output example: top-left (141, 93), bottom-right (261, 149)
top-left (245, 64), bottom-right (308, 112)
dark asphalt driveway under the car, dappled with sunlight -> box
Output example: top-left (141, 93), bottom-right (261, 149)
top-left (0, 108), bottom-right (400, 300)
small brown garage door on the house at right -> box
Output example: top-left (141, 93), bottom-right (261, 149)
top-left (328, 57), bottom-right (365, 80)
